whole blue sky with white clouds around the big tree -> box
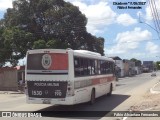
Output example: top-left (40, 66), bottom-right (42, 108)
top-left (0, 0), bottom-right (160, 64)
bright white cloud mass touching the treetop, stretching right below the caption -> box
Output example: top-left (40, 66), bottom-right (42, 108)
top-left (66, 0), bottom-right (137, 34)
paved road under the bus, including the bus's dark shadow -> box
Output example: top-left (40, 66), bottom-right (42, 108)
top-left (0, 72), bottom-right (160, 120)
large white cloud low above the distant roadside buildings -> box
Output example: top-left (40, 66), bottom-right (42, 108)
top-left (106, 28), bottom-right (152, 54)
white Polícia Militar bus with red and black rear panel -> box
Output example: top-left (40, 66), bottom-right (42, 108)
top-left (25, 49), bottom-right (116, 105)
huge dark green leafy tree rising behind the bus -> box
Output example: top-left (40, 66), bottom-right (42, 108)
top-left (0, 0), bottom-right (104, 65)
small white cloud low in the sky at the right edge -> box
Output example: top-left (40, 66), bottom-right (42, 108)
top-left (146, 42), bottom-right (160, 53)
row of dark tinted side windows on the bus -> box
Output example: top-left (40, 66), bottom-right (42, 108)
top-left (74, 57), bottom-right (114, 77)
